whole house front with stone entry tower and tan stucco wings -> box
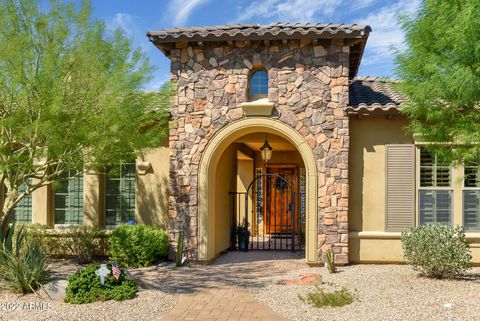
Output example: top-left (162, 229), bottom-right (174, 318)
top-left (3, 23), bottom-right (480, 264)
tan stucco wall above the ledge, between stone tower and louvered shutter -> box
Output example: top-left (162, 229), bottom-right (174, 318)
top-left (348, 116), bottom-right (414, 231)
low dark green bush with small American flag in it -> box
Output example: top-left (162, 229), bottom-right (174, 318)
top-left (65, 263), bottom-right (137, 304)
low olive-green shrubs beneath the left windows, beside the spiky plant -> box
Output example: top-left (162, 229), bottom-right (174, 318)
top-left (28, 224), bottom-right (108, 264)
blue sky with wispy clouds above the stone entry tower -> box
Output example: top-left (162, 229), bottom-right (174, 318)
top-left (74, 0), bottom-right (420, 90)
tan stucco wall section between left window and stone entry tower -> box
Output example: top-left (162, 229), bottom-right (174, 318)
top-left (135, 147), bottom-right (170, 228)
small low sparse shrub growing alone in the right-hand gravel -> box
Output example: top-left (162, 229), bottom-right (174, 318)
top-left (299, 286), bottom-right (355, 308)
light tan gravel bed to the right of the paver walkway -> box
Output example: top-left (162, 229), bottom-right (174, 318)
top-left (250, 265), bottom-right (480, 321)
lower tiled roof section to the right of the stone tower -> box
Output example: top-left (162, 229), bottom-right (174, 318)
top-left (347, 77), bottom-right (406, 113)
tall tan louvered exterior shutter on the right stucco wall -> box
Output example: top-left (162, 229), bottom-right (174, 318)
top-left (385, 144), bottom-right (415, 232)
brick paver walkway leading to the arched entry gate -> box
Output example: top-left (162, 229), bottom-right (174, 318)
top-left (156, 252), bottom-right (304, 321)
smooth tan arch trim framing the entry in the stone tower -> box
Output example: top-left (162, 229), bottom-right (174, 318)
top-left (198, 117), bottom-right (318, 263)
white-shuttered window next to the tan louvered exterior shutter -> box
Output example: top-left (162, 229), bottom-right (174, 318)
top-left (418, 148), bottom-right (453, 224)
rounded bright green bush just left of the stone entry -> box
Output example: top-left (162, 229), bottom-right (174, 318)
top-left (109, 225), bottom-right (168, 267)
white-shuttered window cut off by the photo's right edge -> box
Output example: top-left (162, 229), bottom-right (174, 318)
top-left (463, 163), bottom-right (480, 231)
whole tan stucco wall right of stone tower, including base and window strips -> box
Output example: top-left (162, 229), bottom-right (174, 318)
top-left (348, 116), bottom-right (480, 264)
